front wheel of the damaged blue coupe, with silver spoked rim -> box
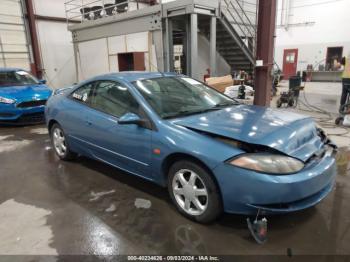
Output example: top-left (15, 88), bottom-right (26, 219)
top-left (168, 161), bottom-right (222, 223)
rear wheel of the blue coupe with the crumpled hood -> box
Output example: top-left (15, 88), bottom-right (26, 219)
top-left (50, 123), bottom-right (77, 160)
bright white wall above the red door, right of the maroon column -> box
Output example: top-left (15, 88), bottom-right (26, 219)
top-left (275, 0), bottom-right (350, 70)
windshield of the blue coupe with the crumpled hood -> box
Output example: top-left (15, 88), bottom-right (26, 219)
top-left (134, 77), bottom-right (238, 119)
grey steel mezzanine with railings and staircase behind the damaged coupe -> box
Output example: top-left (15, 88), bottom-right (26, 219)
top-left (65, 0), bottom-right (262, 79)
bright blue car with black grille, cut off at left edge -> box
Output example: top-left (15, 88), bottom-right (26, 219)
top-left (0, 68), bottom-right (52, 124)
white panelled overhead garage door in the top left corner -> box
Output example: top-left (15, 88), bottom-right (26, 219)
top-left (0, 0), bottom-right (30, 70)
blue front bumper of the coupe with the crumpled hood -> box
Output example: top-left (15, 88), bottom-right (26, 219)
top-left (213, 145), bottom-right (337, 215)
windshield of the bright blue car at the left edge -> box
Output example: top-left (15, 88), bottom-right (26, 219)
top-left (0, 71), bottom-right (39, 87)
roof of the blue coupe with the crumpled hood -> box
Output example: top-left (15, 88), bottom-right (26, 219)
top-left (98, 71), bottom-right (178, 82)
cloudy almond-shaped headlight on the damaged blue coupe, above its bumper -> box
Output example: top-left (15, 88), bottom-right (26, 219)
top-left (229, 153), bottom-right (304, 175)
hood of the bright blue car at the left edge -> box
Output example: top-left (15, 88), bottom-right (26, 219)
top-left (0, 85), bottom-right (52, 101)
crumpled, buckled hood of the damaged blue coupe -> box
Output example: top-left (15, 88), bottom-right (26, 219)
top-left (172, 105), bottom-right (323, 161)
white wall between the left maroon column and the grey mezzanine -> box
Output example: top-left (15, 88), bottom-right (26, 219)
top-left (33, 0), bottom-right (76, 89)
